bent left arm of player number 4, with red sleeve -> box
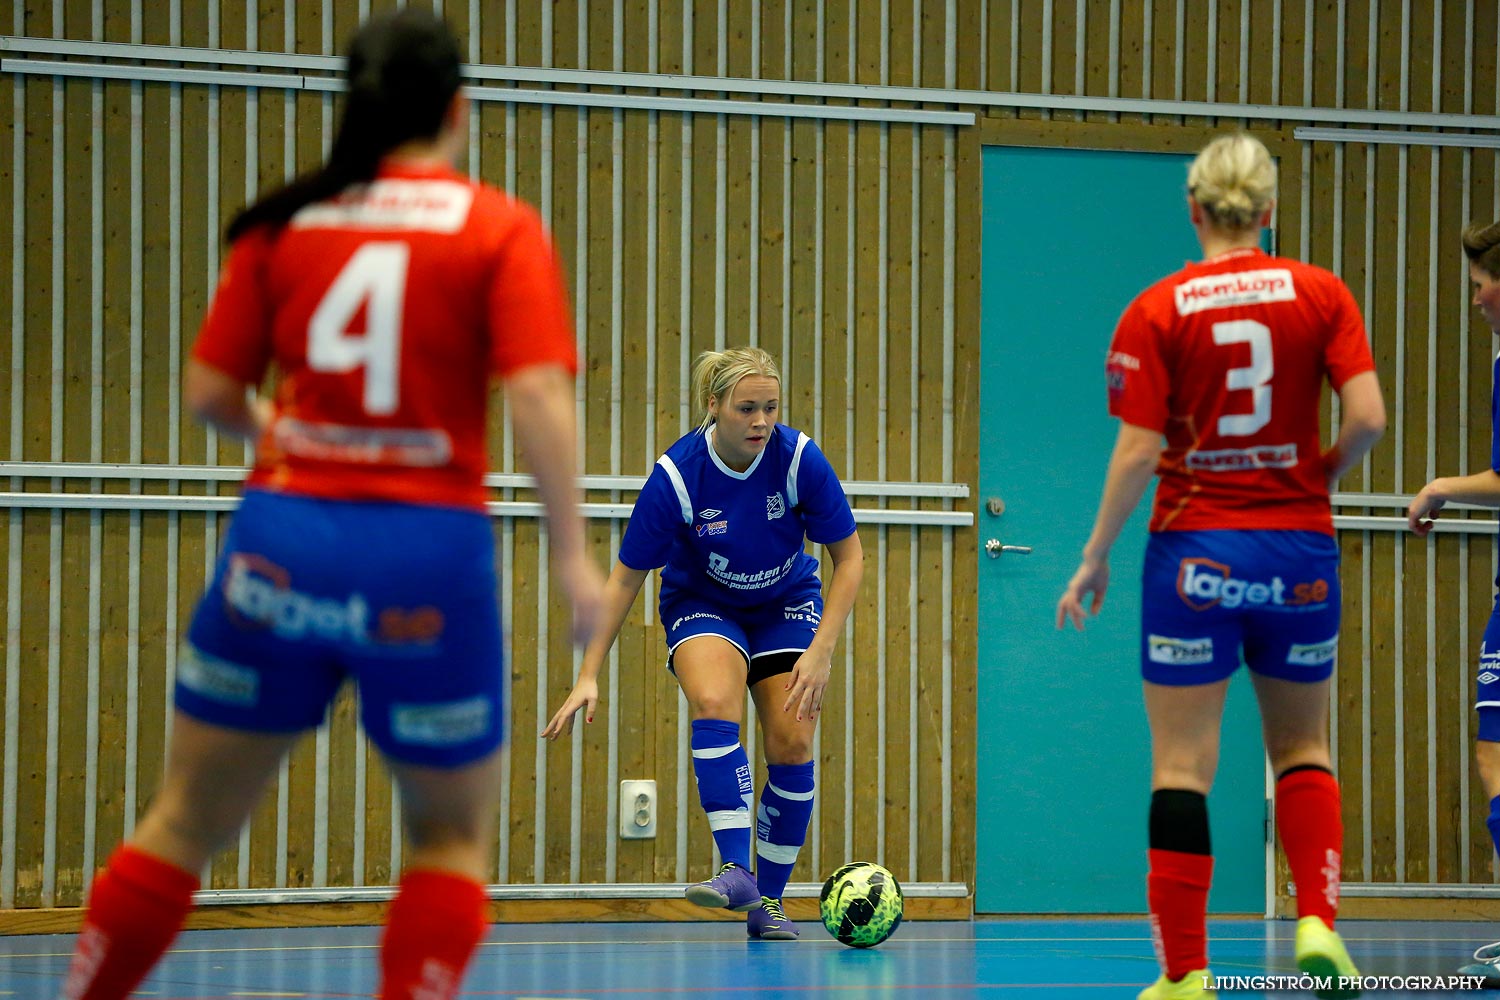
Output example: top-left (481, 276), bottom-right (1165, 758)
top-left (183, 229), bottom-right (273, 439)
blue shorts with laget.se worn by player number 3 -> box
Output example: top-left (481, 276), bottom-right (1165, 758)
top-left (1140, 531), bottom-right (1340, 685)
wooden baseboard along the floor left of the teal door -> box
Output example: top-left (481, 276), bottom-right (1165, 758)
top-left (0, 897), bottom-right (974, 934)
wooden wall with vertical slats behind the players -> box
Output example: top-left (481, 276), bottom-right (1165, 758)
top-left (0, 0), bottom-right (1500, 923)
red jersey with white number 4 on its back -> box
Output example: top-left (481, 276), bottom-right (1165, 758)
top-left (192, 165), bottom-right (578, 508)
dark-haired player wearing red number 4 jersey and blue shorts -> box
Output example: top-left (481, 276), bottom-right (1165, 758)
top-left (62, 9), bottom-right (603, 1000)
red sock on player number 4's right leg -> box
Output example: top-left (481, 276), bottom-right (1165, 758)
top-left (380, 871), bottom-right (489, 1000)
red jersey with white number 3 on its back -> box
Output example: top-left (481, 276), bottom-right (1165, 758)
top-left (1106, 249), bottom-right (1376, 534)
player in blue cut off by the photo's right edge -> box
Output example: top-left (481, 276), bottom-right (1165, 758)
top-left (1407, 222), bottom-right (1500, 990)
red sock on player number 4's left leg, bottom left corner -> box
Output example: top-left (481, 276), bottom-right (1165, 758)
top-left (63, 844), bottom-right (198, 1000)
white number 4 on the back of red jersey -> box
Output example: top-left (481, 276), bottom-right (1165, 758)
top-left (308, 243), bottom-right (411, 417)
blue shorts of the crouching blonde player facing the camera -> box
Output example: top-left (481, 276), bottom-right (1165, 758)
top-left (659, 577), bottom-right (824, 684)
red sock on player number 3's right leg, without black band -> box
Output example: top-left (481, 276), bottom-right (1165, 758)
top-left (1277, 768), bottom-right (1344, 930)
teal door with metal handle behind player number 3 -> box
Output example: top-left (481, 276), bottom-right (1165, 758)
top-left (975, 147), bottom-right (1266, 913)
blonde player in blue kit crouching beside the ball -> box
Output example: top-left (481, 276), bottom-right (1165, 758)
top-left (542, 348), bottom-right (864, 940)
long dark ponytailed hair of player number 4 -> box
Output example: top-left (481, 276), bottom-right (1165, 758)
top-left (225, 7), bottom-right (461, 243)
